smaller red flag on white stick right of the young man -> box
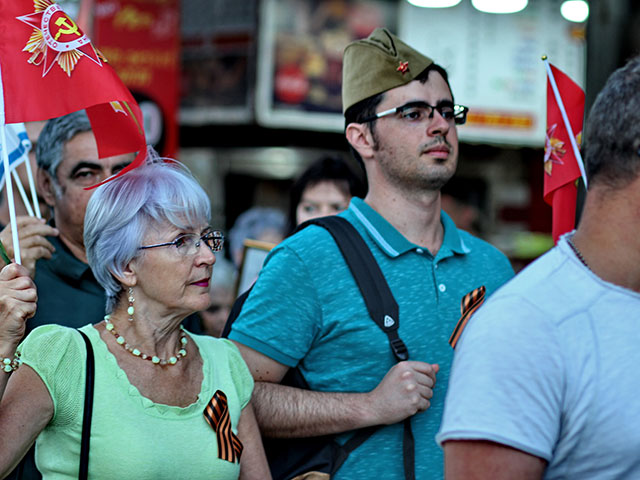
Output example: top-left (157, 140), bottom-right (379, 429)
top-left (544, 64), bottom-right (584, 242)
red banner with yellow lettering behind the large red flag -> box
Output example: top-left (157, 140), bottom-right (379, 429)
top-left (93, 0), bottom-right (180, 157)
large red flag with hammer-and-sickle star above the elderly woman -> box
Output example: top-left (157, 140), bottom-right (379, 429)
top-left (0, 0), bottom-right (146, 184)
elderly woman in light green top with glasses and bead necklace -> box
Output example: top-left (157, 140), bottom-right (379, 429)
top-left (0, 158), bottom-right (270, 480)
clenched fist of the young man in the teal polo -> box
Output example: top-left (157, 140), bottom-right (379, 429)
top-left (369, 361), bottom-right (440, 425)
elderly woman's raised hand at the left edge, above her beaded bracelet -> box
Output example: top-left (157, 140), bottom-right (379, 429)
top-left (0, 263), bottom-right (38, 354)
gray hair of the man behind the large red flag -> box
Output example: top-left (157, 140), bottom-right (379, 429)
top-left (36, 110), bottom-right (91, 186)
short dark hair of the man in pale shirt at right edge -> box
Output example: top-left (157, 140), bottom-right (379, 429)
top-left (584, 56), bottom-right (640, 189)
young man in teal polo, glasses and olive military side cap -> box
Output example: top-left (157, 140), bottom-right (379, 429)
top-left (229, 29), bottom-right (513, 480)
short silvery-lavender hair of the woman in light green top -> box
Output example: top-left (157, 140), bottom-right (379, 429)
top-left (84, 159), bottom-right (211, 313)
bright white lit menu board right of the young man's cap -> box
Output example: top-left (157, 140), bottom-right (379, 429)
top-left (399, 0), bottom-right (586, 147)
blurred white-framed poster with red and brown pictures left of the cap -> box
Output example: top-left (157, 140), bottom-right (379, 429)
top-left (256, 0), bottom-right (397, 131)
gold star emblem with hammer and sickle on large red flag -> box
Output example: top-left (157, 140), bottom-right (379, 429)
top-left (16, 0), bottom-right (106, 77)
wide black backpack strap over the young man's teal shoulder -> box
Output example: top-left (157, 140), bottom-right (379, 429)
top-left (297, 215), bottom-right (409, 362)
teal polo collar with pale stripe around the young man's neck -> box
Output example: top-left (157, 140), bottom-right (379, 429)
top-left (349, 197), bottom-right (470, 257)
